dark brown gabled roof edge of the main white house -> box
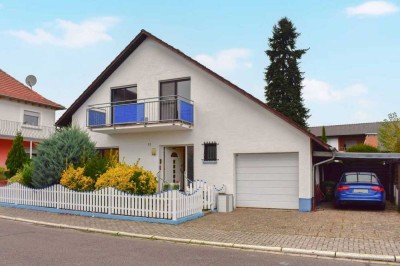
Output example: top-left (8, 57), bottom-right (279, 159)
top-left (56, 30), bottom-right (330, 150)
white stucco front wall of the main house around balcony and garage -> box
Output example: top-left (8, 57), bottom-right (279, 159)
top-left (72, 39), bottom-right (312, 202)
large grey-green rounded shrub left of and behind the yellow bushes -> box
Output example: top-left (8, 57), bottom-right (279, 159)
top-left (32, 127), bottom-right (95, 188)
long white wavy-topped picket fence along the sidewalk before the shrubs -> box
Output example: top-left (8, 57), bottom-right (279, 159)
top-left (0, 183), bottom-right (203, 220)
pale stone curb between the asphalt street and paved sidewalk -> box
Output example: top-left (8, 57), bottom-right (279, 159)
top-left (0, 215), bottom-right (400, 262)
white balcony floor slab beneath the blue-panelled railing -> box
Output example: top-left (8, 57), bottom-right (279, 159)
top-left (89, 121), bottom-right (193, 135)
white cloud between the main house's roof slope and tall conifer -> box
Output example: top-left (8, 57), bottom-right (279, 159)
top-left (194, 48), bottom-right (253, 71)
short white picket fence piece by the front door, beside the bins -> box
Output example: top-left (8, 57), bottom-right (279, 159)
top-left (186, 180), bottom-right (225, 210)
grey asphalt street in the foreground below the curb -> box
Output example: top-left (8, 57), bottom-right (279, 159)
top-left (0, 220), bottom-right (378, 266)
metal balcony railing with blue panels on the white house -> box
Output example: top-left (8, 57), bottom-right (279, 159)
top-left (86, 95), bottom-right (193, 128)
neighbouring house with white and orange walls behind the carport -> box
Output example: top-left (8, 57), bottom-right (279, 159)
top-left (310, 122), bottom-right (381, 151)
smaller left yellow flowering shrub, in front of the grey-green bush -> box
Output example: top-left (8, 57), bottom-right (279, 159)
top-left (60, 164), bottom-right (95, 191)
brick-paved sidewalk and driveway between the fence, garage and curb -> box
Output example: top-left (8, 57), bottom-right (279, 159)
top-left (0, 207), bottom-right (400, 259)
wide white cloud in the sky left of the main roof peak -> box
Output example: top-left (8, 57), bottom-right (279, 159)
top-left (8, 17), bottom-right (119, 48)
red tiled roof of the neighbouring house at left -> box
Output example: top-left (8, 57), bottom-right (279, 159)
top-left (0, 69), bottom-right (65, 110)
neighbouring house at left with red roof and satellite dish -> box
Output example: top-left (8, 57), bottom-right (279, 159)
top-left (0, 69), bottom-right (65, 167)
